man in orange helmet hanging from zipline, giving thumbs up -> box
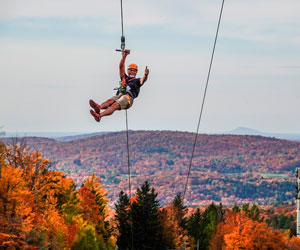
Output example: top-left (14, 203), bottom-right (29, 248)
top-left (89, 50), bottom-right (149, 122)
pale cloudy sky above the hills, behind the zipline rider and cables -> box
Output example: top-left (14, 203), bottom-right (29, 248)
top-left (0, 0), bottom-right (300, 133)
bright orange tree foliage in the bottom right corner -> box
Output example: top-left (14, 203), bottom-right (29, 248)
top-left (209, 211), bottom-right (300, 250)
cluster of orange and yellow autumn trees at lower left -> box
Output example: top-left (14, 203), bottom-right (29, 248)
top-left (0, 144), bottom-right (115, 249)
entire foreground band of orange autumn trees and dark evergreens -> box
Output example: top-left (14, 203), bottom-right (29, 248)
top-left (0, 144), bottom-right (300, 250)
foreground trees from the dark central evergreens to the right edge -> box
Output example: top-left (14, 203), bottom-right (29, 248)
top-left (115, 182), bottom-right (300, 250)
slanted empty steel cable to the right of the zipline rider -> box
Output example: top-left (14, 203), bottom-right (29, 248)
top-left (182, 0), bottom-right (224, 202)
